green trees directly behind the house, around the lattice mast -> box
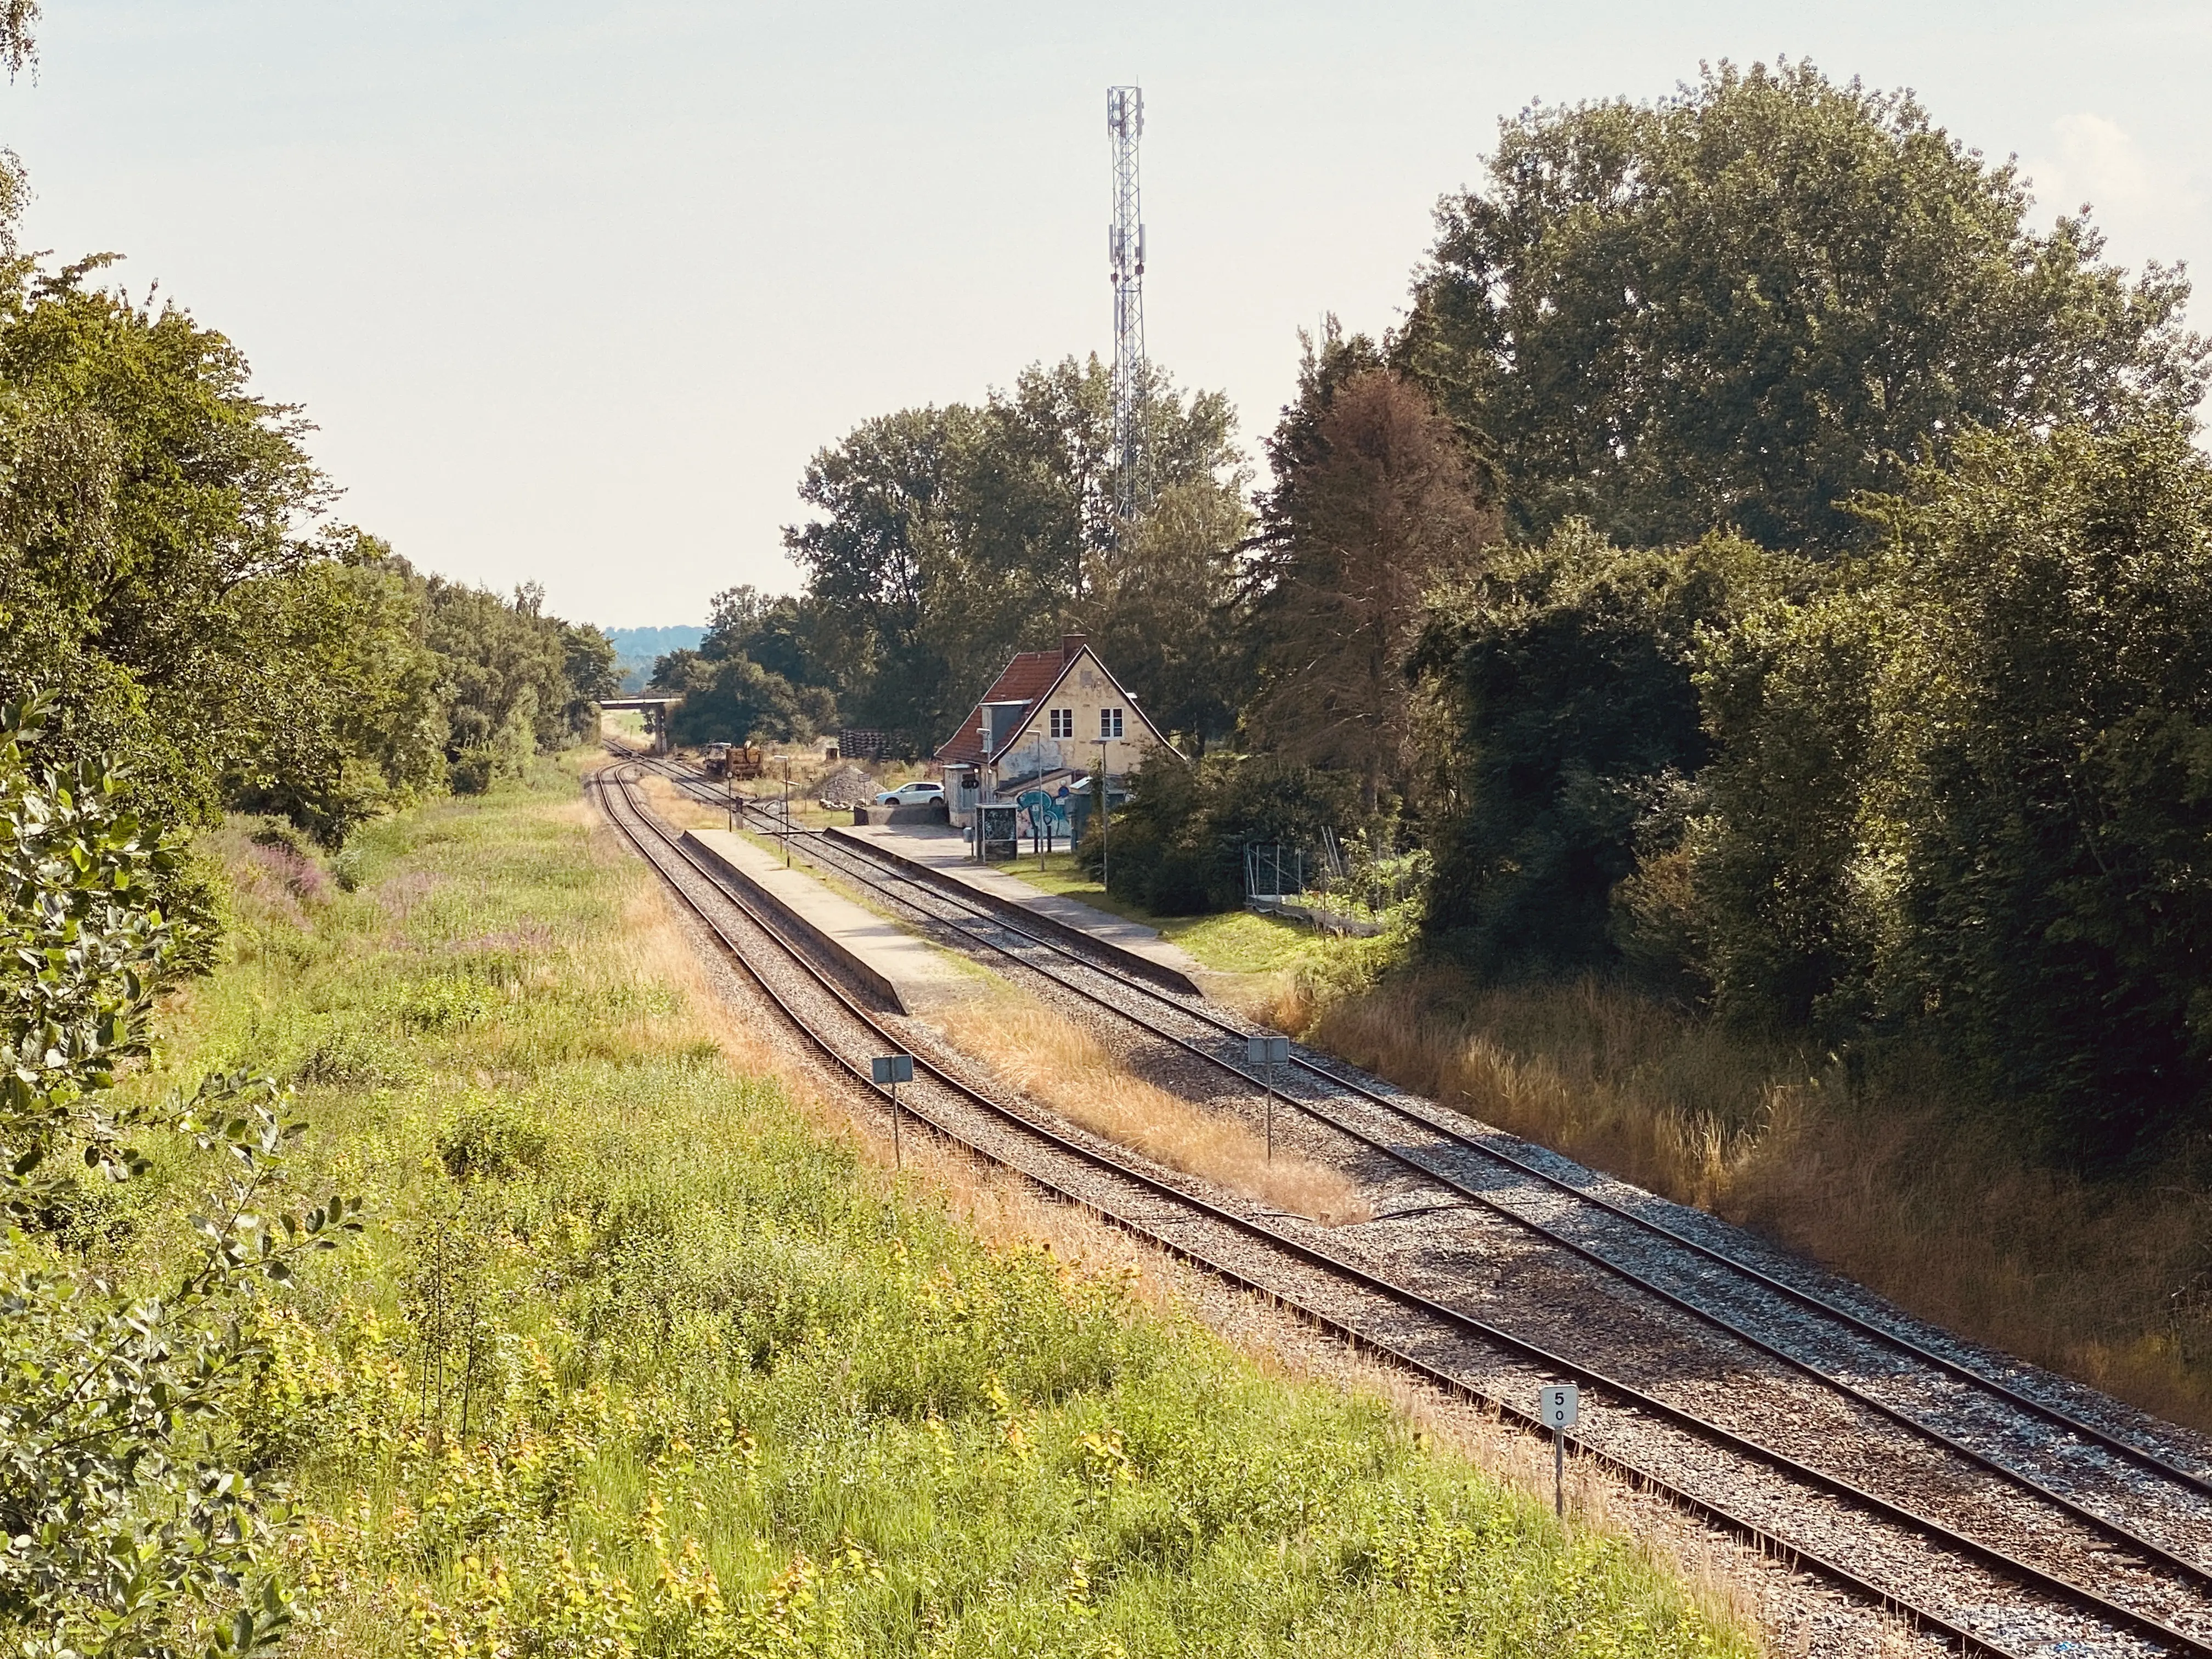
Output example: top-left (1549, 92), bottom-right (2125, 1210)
top-left (785, 358), bottom-right (1245, 748)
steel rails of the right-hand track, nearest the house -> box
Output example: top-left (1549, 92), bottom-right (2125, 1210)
top-left (646, 756), bottom-right (2212, 1522)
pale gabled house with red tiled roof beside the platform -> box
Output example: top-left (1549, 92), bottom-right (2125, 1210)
top-left (936, 633), bottom-right (1170, 825)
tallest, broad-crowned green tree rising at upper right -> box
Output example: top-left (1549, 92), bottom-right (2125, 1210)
top-left (1396, 62), bottom-right (2205, 551)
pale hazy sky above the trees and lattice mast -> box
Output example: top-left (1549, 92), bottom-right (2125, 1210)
top-left (0, 0), bottom-right (2212, 626)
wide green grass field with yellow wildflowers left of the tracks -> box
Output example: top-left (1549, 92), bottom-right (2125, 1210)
top-left (108, 774), bottom-right (1754, 1659)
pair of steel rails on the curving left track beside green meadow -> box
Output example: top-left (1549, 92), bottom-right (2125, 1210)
top-left (600, 778), bottom-right (2212, 1655)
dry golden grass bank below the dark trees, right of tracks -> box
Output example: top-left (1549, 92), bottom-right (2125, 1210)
top-left (1265, 971), bottom-right (2212, 1429)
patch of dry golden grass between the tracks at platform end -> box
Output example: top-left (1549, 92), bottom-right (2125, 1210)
top-left (938, 991), bottom-right (1367, 1226)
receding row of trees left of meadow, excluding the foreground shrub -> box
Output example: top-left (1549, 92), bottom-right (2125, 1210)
top-left (0, 163), bottom-right (615, 845)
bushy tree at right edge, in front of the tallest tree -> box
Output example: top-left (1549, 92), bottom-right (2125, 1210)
top-left (1695, 420), bottom-right (2212, 1159)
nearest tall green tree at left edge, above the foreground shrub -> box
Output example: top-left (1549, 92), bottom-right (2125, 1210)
top-left (0, 245), bottom-right (330, 823)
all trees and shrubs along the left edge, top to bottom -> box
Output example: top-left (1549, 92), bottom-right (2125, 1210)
top-left (0, 61), bottom-right (613, 1659)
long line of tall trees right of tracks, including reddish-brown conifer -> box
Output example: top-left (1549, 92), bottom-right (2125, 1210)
top-left (756, 62), bottom-right (2212, 1157)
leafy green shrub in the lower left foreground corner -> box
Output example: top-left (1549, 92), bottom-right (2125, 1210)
top-left (0, 701), bottom-right (358, 1659)
